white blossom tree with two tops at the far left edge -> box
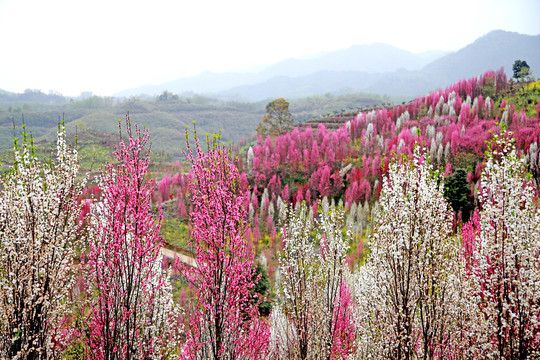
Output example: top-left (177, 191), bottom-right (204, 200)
top-left (0, 124), bottom-right (85, 359)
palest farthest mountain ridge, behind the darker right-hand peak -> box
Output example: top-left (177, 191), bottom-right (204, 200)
top-left (116, 44), bottom-right (448, 100)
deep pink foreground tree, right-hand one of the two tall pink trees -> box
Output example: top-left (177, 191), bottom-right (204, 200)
top-left (182, 133), bottom-right (269, 359)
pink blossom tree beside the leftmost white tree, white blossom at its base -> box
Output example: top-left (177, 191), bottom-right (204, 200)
top-left (83, 115), bottom-right (181, 360)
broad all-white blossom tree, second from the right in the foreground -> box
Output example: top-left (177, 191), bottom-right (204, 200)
top-left (354, 147), bottom-right (463, 359)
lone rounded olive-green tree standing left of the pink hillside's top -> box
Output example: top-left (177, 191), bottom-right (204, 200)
top-left (257, 98), bottom-right (294, 137)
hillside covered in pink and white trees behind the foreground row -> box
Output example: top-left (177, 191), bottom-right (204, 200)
top-left (153, 70), bottom-right (540, 275)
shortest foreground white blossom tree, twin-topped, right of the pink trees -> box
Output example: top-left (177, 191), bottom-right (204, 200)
top-left (271, 205), bottom-right (355, 359)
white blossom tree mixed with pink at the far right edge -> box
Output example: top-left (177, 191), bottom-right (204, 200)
top-left (463, 133), bottom-right (540, 359)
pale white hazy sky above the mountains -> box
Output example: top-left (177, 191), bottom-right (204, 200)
top-left (0, 0), bottom-right (540, 96)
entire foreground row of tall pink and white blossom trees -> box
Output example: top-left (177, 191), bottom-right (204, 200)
top-left (0, 97), bottom-right (540, 359)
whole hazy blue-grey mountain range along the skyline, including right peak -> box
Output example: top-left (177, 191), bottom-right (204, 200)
top-left (116, 30), bottom-right (540, 101)
